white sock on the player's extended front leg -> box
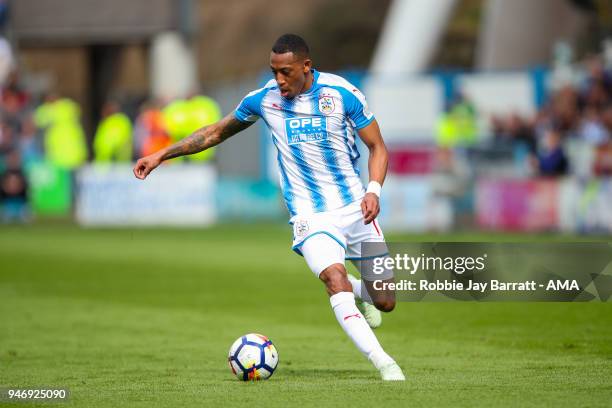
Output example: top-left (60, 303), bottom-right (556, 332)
top-left (329, 292), bottom-right (393, 368)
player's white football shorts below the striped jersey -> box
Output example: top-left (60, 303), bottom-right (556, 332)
top-left (291, 200), bottom-right (392, 279)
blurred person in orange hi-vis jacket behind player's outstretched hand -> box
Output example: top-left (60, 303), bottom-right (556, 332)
top-left (134, 102), bottom-right (171, 157)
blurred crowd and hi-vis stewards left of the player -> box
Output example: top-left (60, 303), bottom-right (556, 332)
top-left (0, 53), bottom-right (221, 222)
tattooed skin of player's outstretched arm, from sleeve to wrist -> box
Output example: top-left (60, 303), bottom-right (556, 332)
top-left (163, 112), bottom-right (253, 160)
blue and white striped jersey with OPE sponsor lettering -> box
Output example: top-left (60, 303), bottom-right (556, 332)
top-left (234, 70), bottom-right (374, 217)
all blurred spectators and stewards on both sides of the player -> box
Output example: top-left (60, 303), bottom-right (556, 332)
top-left (0, 49), bottom-right (612, 225)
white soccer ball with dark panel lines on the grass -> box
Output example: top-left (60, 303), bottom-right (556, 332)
top-left (227, 333), bottom-right (278, 381)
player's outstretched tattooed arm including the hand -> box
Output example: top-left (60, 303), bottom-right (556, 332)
top-left (134, 112), bottom-right (253, 180)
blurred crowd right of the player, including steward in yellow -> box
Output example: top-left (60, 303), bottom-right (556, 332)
top-left (436, 55), bottom-right (612, 177)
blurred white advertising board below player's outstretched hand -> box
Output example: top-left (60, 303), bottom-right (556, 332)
top-left (76, 164), bottom-right (217, 226)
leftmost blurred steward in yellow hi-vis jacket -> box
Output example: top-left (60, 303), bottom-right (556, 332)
top-left (34, 94), bottom-right (87, 170)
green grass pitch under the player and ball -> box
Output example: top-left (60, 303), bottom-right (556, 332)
top-left (0, 225), bottom-right (612, 407)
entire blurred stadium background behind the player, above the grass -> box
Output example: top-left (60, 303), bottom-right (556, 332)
top-left (0, 0), bottom-right (612, 232)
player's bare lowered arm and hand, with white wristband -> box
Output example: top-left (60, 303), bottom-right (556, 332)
top-left (358, 119), bottom-right (389, 224)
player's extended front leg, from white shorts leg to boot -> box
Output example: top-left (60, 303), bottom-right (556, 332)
top-left (301, 234), bottom-right (404, 380)
